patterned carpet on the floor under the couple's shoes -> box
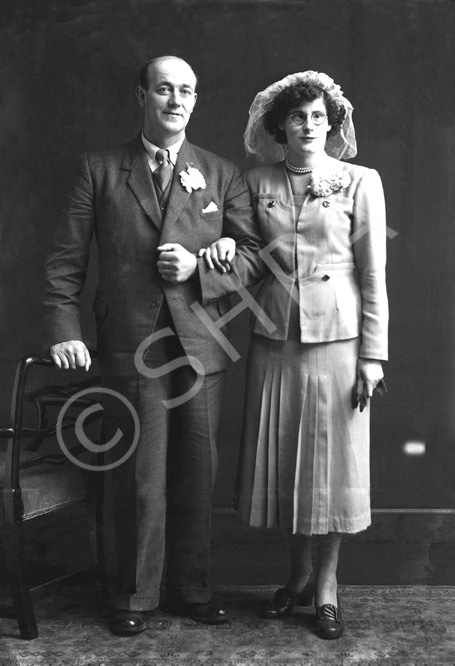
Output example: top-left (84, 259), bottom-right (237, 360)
top-left (0, 586), bottom-right (455, 666)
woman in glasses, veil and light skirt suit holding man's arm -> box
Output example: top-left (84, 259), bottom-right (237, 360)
top-left (201, 71), bottom-right (388, 638)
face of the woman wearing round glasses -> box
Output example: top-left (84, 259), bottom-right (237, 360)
top-left (280, 97), bottom-right (330, 165)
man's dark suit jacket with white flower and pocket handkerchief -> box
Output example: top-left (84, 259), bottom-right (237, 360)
top-left (45, 137), bottom-right (262, 373)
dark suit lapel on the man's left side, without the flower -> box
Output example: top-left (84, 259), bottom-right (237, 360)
top-left (120, 137), bottom-right (162, 229)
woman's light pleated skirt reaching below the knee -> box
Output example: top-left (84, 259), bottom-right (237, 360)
top-left (237, 335), bottom-right (371, 535)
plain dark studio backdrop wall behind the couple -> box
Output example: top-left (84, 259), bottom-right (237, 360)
top-left (0, 0), bottom-right (455, 538)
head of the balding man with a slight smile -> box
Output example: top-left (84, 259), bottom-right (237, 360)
top-left (136, 59), bottom-right (197, 148)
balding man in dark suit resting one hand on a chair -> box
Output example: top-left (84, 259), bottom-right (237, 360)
top-left (45, 56), bottom-right (261, 634)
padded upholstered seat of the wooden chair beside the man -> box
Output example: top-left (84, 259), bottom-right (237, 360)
top-left (0, 451), bottom-right (95, 520)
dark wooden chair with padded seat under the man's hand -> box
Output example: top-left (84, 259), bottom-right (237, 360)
top-left (0, 356), bottom-right (108, 640)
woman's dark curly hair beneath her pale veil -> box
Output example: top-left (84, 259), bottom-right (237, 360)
top-left (264, 82), bottom-right (346, 143)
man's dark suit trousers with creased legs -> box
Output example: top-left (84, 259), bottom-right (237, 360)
top-left (101, 306), bottom-right (226, 611)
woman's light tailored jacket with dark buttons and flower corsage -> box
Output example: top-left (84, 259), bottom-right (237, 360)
top-left (245, 158), bottom-right (388, 360)
